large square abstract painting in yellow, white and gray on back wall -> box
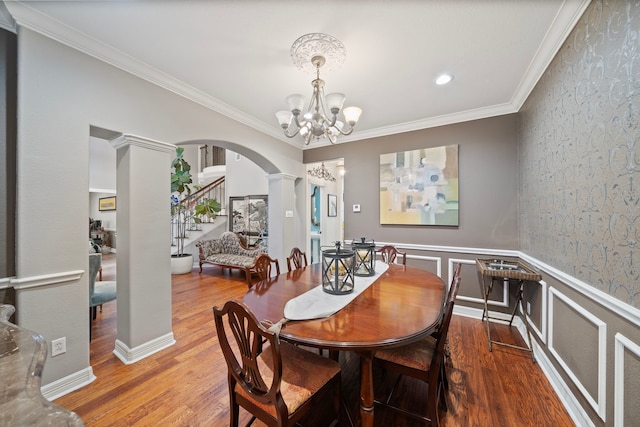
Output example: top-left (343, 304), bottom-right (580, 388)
top-left (379, 144), bottom-right (460, 227)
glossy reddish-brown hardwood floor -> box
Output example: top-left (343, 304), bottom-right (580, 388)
top-left (55, 255), bottom-right (574, 427)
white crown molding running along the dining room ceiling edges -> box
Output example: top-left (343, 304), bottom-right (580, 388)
top-left (5, 0), bottom-right (591, 150)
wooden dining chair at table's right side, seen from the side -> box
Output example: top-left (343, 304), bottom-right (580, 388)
top-left (373, 268), bottom-right (460, 426)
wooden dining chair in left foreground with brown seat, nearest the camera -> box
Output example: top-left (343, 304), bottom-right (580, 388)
top-left (213, 301), bottom-right (341, 426)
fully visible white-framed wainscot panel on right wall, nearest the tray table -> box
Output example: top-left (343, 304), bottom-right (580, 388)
top-left (548, 287), bottom-right (607, 421)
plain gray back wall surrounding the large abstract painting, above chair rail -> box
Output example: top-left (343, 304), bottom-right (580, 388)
top-left (303, 115), bottom-right (518, 249)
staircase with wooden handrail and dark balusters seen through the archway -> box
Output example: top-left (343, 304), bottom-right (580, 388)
top-left (171, 176), bottom-right (228, 261)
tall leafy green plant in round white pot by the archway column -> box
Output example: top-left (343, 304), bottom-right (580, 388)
top-left (171, 147), bottom-right (221, 274)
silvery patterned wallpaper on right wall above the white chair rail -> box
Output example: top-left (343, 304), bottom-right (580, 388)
top-left (519, 0), bottom-right (640, 308)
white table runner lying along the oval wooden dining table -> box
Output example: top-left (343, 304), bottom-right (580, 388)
top-left (284, 262), bottom-right (389, 320)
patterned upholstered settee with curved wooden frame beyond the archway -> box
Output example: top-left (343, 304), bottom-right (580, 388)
top-left (196, 231), bottom-right (267, 286)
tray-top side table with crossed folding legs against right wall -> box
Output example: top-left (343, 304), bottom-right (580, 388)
top-left (476, 259), bottom-right (542, 362)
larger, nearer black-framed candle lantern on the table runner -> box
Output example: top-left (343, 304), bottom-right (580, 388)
top-left (322, 242), bottom-right (355, 295)
